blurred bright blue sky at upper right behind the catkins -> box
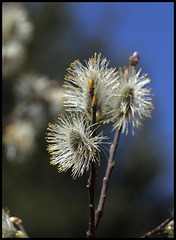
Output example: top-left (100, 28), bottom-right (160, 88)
top-left (69, 2), bottom-right (174, 197)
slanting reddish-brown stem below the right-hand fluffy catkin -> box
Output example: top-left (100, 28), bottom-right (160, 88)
top-left (95, 129), bottom-right (121, 230)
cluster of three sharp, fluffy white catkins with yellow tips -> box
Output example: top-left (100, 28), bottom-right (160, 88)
top-left (46, 53), bottom-right (153, 179)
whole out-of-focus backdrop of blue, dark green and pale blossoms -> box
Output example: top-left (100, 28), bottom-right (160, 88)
top-left (2, 2), bottom-right (174, 238)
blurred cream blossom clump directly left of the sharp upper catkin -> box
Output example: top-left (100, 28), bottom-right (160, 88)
top-left (14, 73), bottom-right (64, 119)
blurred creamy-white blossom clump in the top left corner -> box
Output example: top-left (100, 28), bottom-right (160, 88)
top-left (2, 2), bottom-right (33, 77)
